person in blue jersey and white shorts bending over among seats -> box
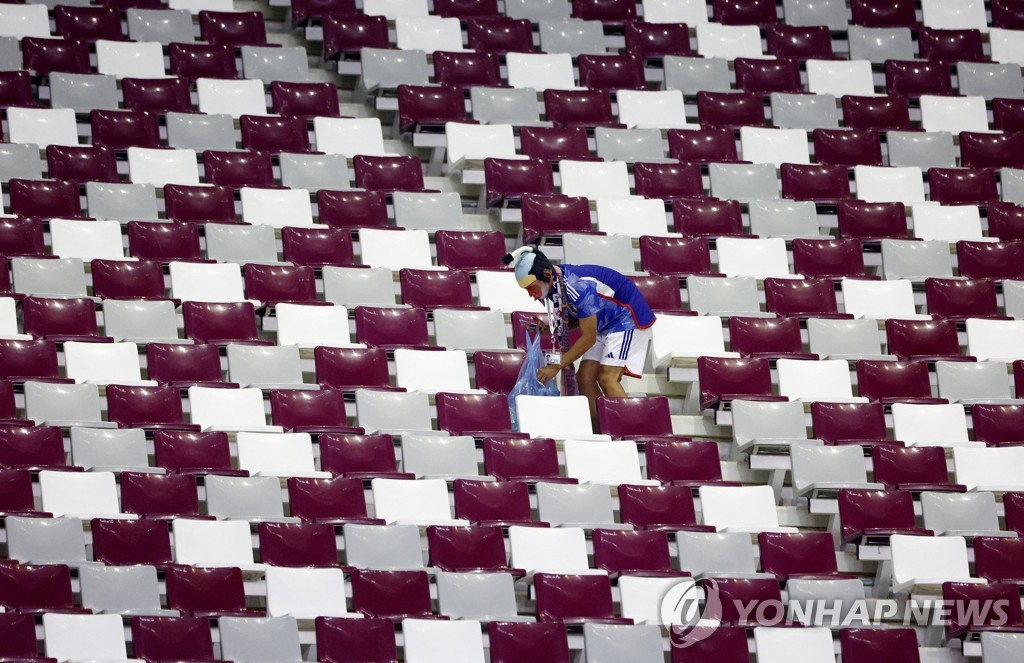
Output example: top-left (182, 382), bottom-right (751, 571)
top-left (505, 246), bottom-right (655, 431)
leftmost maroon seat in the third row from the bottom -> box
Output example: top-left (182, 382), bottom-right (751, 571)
top-left (91, 519), bottom-right (171, 568)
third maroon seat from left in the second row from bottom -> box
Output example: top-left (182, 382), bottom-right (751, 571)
top-left (351, 569), bottom-right (432, 620)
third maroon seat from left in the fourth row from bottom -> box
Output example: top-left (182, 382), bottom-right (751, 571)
top-left (284, 476), bottom-right (384, 524)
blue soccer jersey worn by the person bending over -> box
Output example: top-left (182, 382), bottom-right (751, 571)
top-left (559, 264), bottom-right (654, 334)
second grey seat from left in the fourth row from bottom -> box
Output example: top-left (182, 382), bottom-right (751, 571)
top-left (532, 482), bottom-right (629, 528)
